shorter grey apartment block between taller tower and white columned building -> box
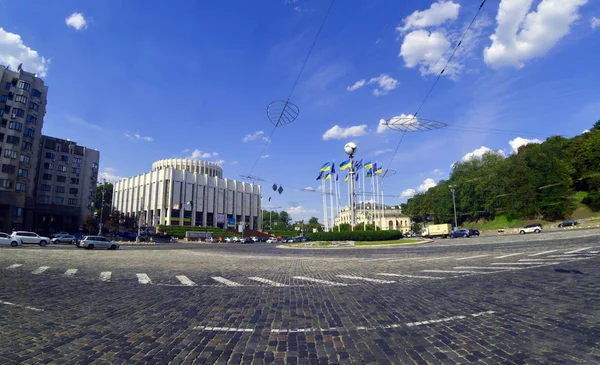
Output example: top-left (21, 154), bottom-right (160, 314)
top-left (33, 136), bottom-right (100, 232)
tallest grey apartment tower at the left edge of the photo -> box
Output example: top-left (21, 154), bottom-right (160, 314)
top-left (0, 65), bottom-right (48, 233)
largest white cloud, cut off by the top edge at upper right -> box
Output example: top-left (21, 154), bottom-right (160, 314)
top-left (483, 0), bottom-right (588, 68)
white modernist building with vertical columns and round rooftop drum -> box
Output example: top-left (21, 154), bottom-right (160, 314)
top-left (113, 158), bottom-right (261, 229)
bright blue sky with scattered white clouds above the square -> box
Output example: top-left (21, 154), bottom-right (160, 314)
top-left (0, 0), bottom-right (600, 219)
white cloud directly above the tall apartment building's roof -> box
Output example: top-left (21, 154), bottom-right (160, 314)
top-left (0, 27), bottom-right (50, 77)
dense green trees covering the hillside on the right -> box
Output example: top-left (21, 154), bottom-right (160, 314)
top-left (403, 121), bottom-right (600, 225)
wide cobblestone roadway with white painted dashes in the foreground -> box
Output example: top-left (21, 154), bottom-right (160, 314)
top-left (0, 230), bottom-right (600, 365)
